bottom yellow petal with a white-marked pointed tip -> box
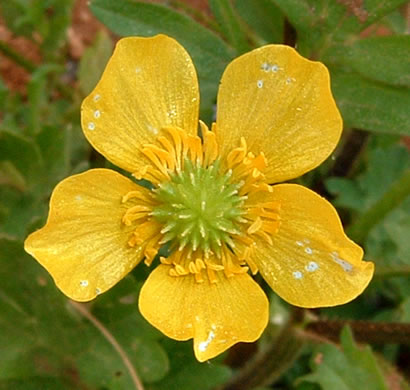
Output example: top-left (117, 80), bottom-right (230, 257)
top-left (139, 265), bottom-right (269, 362)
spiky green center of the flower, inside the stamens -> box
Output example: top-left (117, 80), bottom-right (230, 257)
top-left (151, 159), bottom-right (245, 256)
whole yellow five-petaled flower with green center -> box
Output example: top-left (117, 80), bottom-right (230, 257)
top-left (25, 35), bottom-right (373, 361)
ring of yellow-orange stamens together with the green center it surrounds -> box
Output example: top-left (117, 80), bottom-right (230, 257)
top-left (122, 126), bottom-right (280, 283)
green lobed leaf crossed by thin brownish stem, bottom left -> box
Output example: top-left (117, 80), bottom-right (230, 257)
top-left (77, 282), bottom-right (169, 389)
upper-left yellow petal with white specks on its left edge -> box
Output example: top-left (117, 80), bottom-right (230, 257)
top-left (81, 35), bottom-right (199, 172)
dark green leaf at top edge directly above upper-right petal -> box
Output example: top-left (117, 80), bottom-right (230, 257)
top-left (234, 0), bottom-right (284, 43)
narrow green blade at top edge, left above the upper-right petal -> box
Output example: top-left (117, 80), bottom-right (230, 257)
top-left (209, 0), bottom-right (250, 53)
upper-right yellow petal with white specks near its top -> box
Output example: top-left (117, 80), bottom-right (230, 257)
top-left (216, 45), bottom-right (342, 183)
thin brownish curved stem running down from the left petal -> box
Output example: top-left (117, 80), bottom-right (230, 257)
top-left (69, 301), bottom-right (144, 390)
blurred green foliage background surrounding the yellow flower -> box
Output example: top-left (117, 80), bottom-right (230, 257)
top-left (0, 0), bottom-right (410, 390)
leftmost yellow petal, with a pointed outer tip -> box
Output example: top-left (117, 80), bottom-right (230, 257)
top-left (25, 169), bottom-right (147, 301)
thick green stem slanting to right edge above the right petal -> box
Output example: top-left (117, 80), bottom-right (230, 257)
top-left (347, 169), bottom-right (410, 243)
